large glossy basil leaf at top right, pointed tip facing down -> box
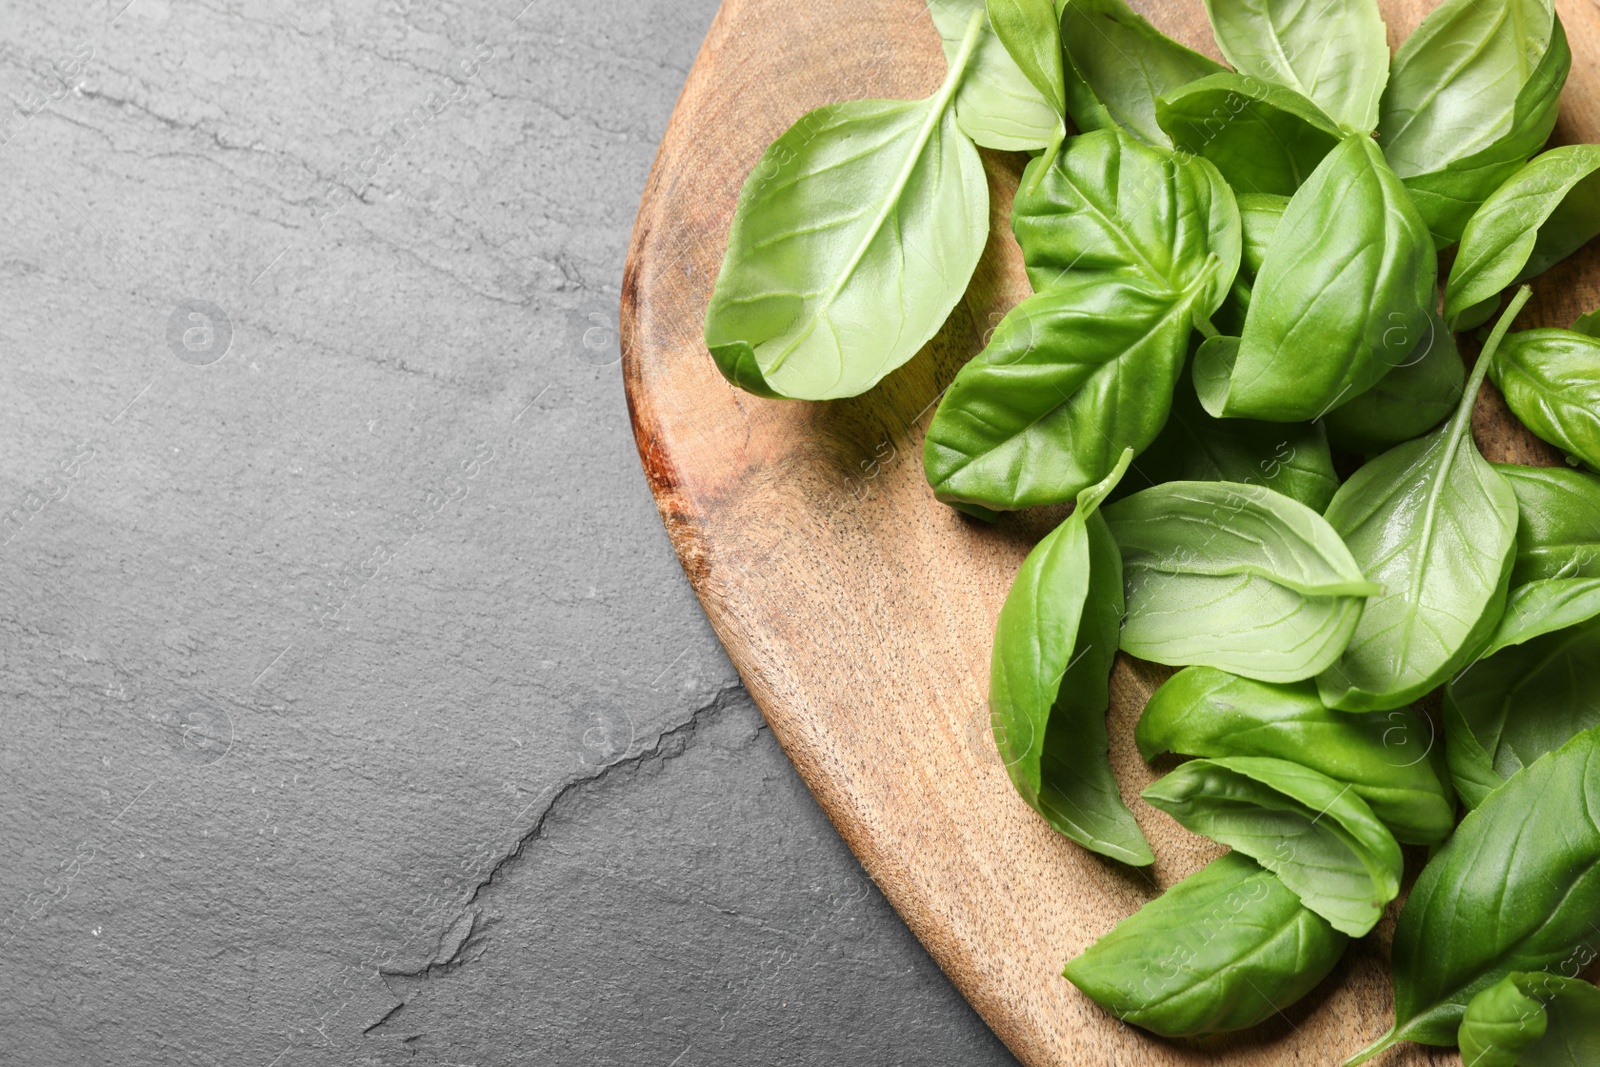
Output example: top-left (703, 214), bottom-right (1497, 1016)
top-left (1379, 0), bottom-right (1573, 246)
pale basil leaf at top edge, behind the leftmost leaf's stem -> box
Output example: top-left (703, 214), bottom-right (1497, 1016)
top-left (928, 0), bottom-right (1066, 152)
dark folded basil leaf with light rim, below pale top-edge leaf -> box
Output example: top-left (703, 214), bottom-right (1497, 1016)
top-left (1155, 74), bottom-right (1341, 197)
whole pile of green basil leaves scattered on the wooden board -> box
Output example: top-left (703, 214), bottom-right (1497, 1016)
top-left (706, 0), bottom-right (1600, 1064)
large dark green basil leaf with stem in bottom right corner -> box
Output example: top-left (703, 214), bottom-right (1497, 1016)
top-left (1349, 731), bottom-right (1600, 1067)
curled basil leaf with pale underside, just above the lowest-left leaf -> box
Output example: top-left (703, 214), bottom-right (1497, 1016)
top-left (1142, 757), bottom-right (1405, 937)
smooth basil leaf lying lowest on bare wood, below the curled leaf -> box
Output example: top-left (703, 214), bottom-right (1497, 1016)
top-left (1066, 853), bottom-right (1349, 1037)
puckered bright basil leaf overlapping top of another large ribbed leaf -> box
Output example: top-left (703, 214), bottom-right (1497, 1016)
top-left (1011, 130), bottom-right (1240, 315)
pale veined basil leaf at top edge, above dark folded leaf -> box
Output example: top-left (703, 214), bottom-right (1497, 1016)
top-left (1205, 0), bottom-right (1389, 134)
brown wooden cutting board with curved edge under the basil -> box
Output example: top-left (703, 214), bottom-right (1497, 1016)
top-left (622, 0), bottom-right (1600, 1067)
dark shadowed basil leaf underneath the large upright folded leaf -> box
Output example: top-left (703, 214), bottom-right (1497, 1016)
top-left (1322, 309), bottom-right (1467, 456)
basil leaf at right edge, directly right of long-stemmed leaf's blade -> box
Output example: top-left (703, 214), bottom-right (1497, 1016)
top-left (1494, 464), bottom-right (1600, 585)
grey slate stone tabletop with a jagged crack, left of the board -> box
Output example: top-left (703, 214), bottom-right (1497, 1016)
top-left (0, 0), bottom-right (1010, 1067)
